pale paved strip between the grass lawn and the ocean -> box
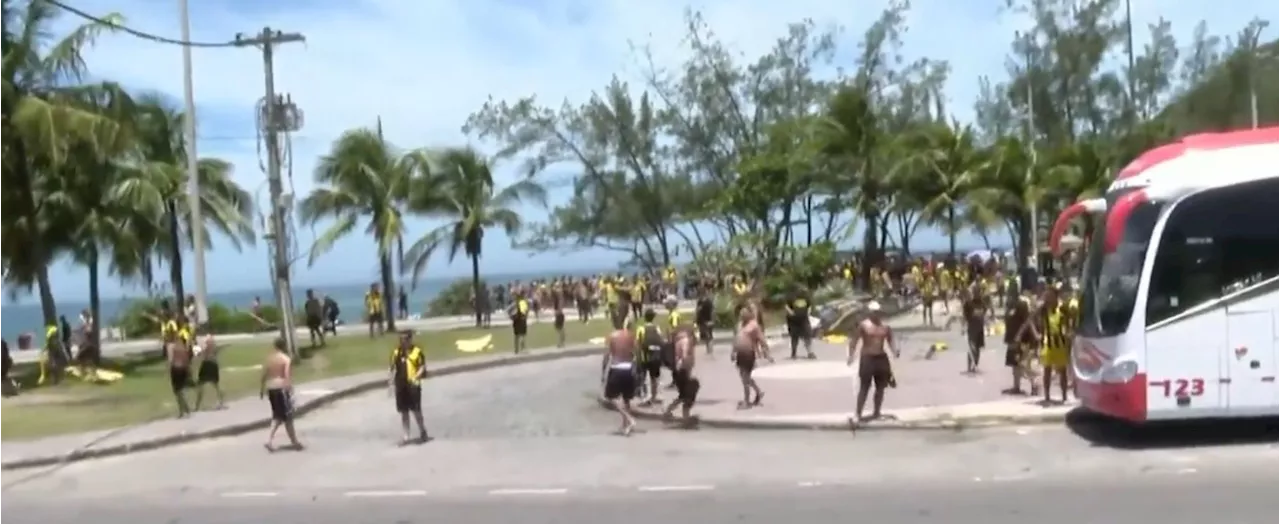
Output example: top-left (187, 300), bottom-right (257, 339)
top-left (13, 301), bottom-right (694, 364)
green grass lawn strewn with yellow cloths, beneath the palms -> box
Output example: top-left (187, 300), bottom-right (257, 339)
top-left (0, 319), bottom-right (609, 441)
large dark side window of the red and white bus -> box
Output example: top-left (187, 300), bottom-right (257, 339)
top-left (1147, 179), bottom-right (1280, 325)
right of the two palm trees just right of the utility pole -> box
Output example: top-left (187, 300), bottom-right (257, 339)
top-left (406, 147), bottom-right (547, 327)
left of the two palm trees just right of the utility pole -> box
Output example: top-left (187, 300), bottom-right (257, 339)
top-left (298, 128), bottom-right (429, 331)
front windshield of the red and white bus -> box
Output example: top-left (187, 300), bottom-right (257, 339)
top-left (1079, 188), bottom-right (1161, 337)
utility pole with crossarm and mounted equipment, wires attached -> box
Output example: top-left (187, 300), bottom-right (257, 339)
top-left (236, 27), bottom-right (306, 356)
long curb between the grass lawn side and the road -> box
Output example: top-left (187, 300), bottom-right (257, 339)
top-left (0, 347), bottom-right (600, 471)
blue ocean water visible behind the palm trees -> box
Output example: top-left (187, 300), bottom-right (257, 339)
top-left (0, 269), bottom-right (616, 343)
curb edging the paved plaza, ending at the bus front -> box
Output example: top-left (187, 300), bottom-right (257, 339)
top-left (595, 397), bottom-right (1075, 433)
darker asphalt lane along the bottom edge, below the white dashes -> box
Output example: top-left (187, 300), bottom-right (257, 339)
top-left (0, 469), bottom-right (1276, 524)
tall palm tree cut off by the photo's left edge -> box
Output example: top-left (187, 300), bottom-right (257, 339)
top-left (0, 0), bottom-right (120, 324)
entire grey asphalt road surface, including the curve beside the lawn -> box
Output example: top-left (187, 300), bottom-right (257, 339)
top-left (0, 348), bottom-right (1280, 524)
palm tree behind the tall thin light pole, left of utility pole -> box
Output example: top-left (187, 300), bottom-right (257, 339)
top-left (136, 94), bottom-right (255, 304)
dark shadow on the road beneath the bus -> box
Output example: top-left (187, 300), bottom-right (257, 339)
top-left (1066, 409), bottom-right (1280, 450)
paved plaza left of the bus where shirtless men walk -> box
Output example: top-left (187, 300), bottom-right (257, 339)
top-left (614, 305), bottom-right (1074, 430)
